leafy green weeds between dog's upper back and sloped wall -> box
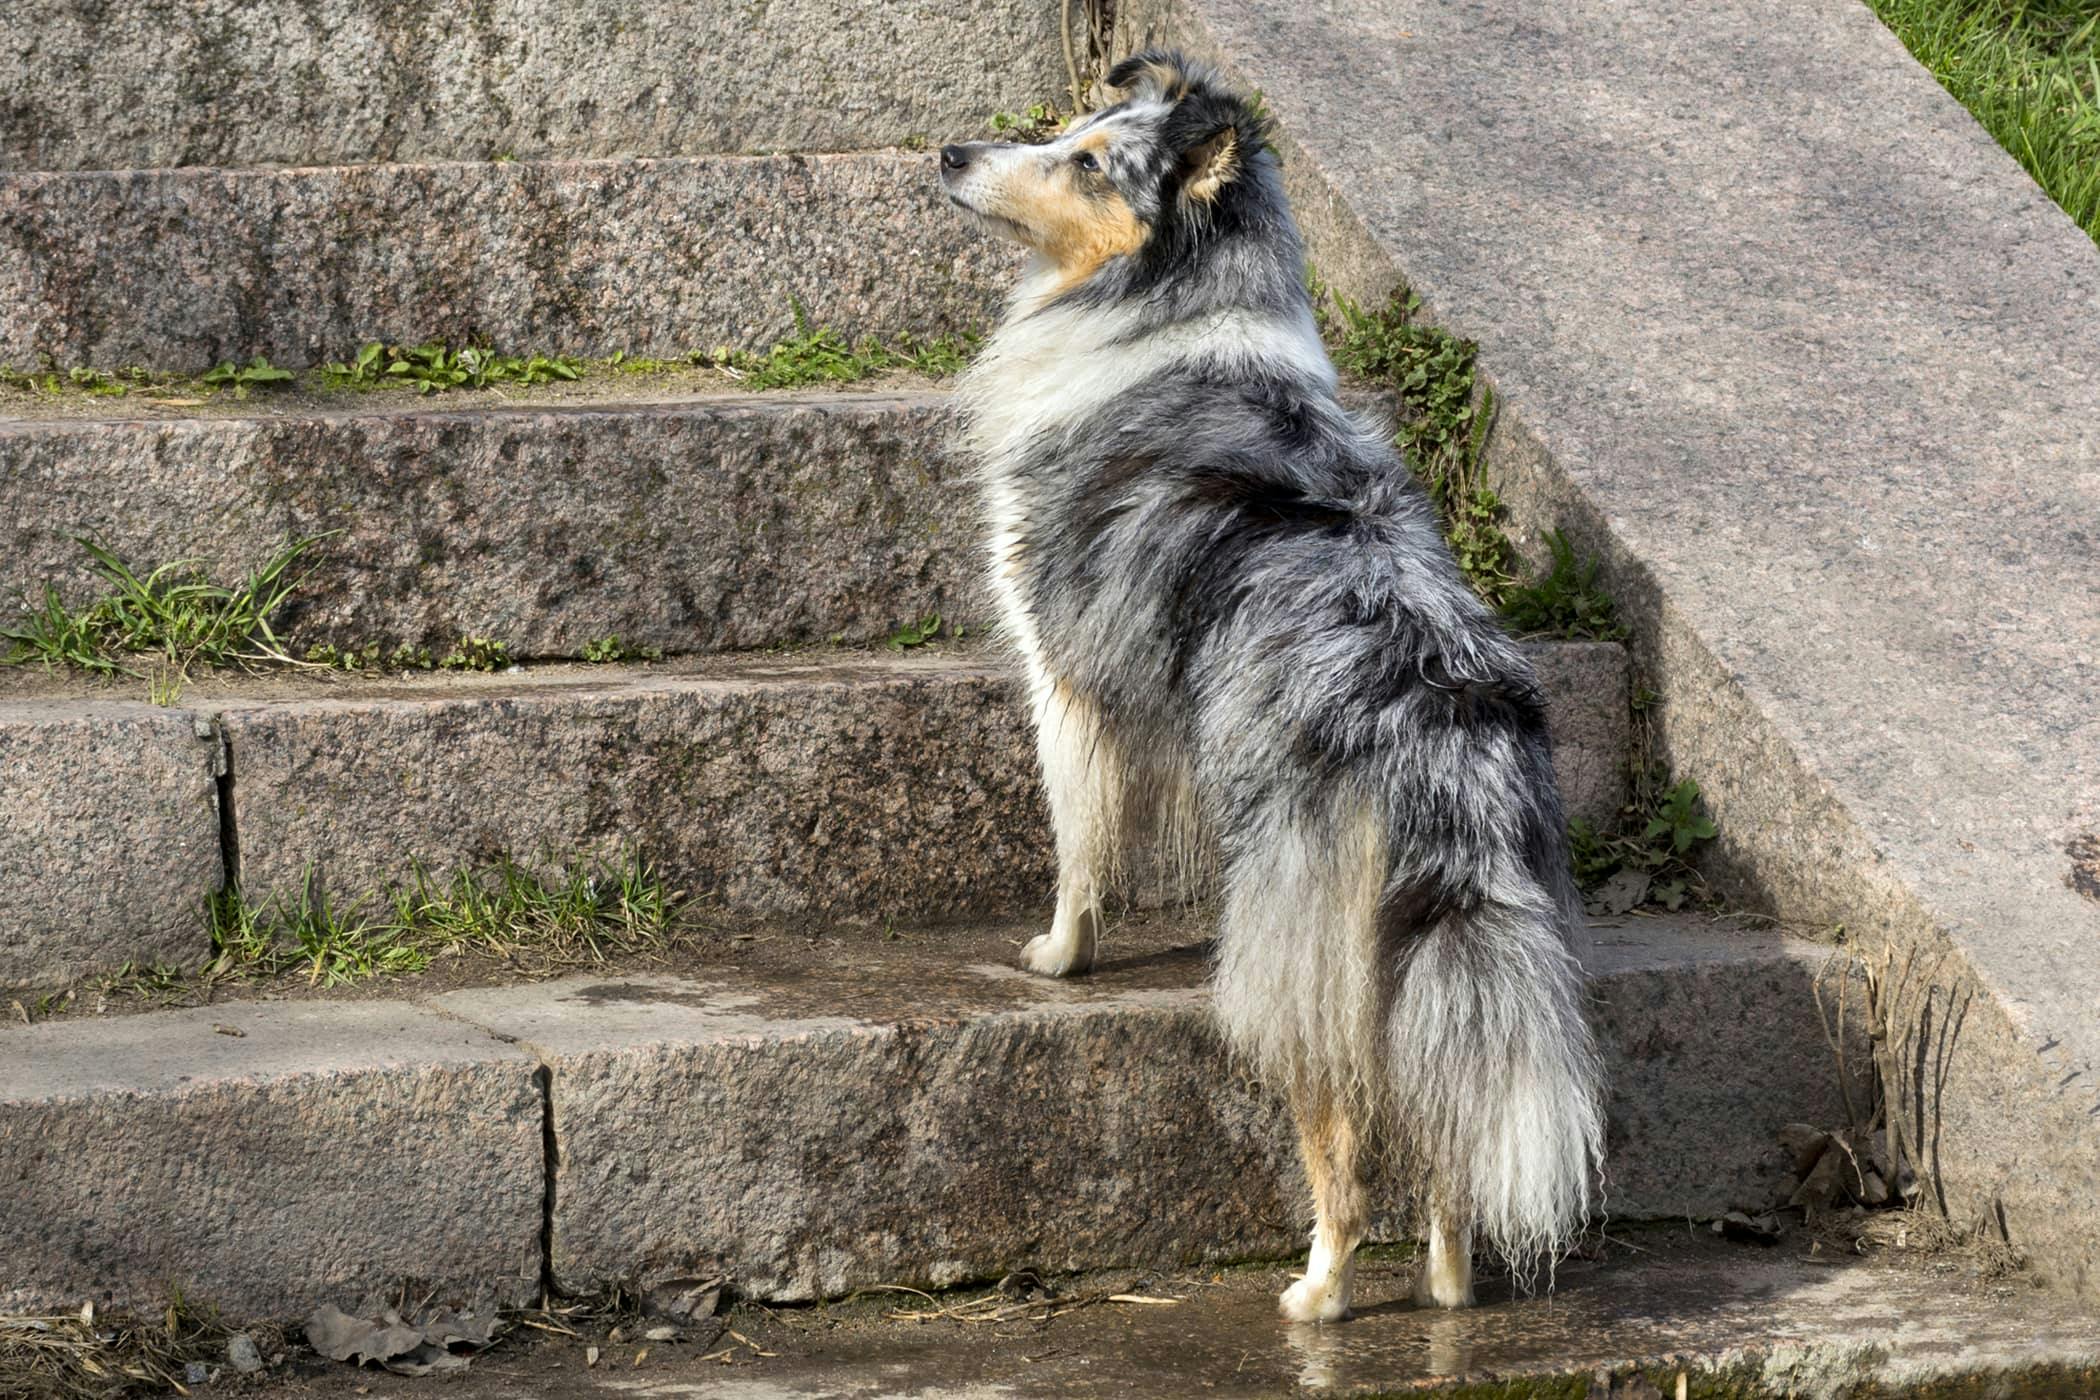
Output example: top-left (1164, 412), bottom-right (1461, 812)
top-left (1313, 287), bottom-right (1523, 607)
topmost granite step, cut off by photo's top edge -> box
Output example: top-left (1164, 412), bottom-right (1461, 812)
top-left (0, 0), bottom-right (1065, 170)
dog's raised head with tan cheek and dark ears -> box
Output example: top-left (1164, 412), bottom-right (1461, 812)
top-left (941, 50), bottom-right (1275, 290)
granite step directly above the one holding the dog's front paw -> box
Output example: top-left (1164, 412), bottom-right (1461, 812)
top-left (0, 644), bottom-right (1630, 987)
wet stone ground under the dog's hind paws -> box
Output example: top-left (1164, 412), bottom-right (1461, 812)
top-left (238, 1228), bottom-right (2100, 1400)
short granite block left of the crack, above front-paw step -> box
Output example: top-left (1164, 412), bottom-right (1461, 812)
top-left (0, 701), bottom-right (223, 987)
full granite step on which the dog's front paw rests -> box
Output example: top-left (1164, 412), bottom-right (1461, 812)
top-left (0, 915), bottom-right (1842, 1316)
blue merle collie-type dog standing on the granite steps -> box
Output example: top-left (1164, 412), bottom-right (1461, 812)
top-left (941, 50), bottom-right (1604, 1322)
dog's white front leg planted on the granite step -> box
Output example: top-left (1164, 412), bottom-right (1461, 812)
top-left (1021, 676), bottom-right (1126, 978)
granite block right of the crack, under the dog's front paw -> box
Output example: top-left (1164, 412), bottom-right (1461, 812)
top-left (437, 921), bottom-right (1835, 1299)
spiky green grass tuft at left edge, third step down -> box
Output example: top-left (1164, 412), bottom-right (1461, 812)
top-left (0, 535), bottom-right (326, 676)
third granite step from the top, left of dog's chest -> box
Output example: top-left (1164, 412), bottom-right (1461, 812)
top-left (0, 393), bottom-right (987, 657)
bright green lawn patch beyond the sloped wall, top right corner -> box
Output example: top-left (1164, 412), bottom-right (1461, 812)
top-left (1867, 0), bottom-right (2100, 243)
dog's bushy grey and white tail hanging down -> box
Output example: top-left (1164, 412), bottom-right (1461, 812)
top-left (1384, 882), bottom-right (1604, 1276)
